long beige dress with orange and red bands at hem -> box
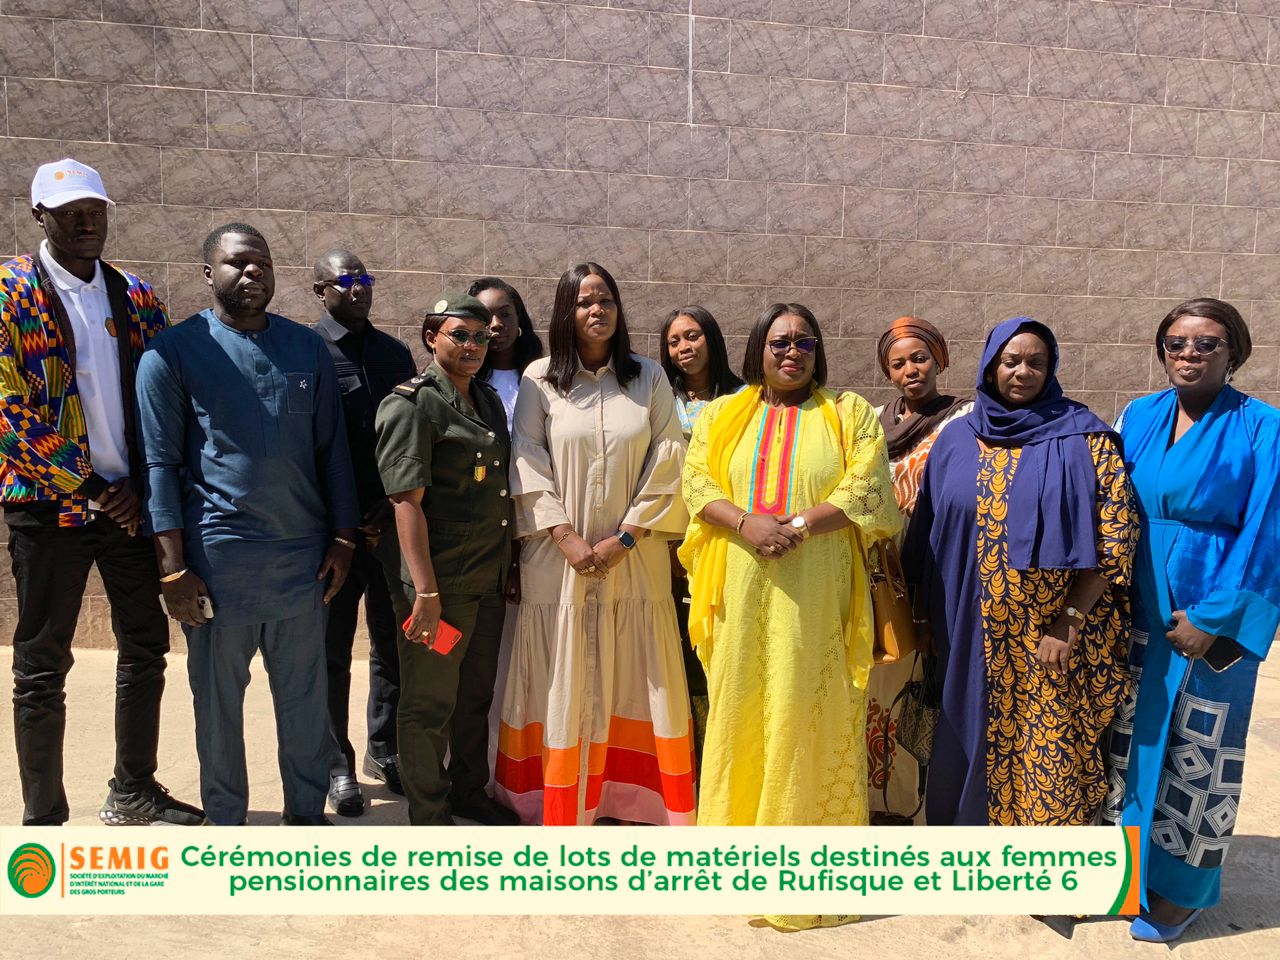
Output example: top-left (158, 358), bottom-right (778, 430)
top-left (495, 358), bottom-right (694, 824)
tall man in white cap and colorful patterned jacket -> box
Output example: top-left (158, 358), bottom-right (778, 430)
top-left (0, 159), bottom-right (204, 824)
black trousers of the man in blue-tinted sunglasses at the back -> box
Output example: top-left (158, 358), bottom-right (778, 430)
top-left (324, 544), bottom-right (399, 777)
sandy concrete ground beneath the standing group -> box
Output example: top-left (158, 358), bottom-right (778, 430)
top-left (0, 648), bottom-right (1280, 960)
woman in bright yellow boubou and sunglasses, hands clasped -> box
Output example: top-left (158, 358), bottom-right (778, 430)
top-left (680, 303), bottom-right (901, 928)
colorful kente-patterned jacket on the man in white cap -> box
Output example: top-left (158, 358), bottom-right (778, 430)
top-left (0, 255), bottom-right (168, 526)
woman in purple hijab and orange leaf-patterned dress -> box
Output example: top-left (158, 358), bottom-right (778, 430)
top-left (904, 316), bottom-right (1138, 826)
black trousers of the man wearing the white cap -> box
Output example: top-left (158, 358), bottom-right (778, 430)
top-left (5, 509), bottom-right (169, 824)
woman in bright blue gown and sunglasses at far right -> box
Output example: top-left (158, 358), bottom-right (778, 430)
top-left (1105, 300), bottom-right (1280, 942)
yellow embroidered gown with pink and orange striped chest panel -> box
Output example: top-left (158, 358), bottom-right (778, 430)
top-left (684, 393), bottom-right (901, 927)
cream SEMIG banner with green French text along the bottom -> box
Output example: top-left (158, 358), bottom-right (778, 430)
top-left (0, 827), bottom-right (1138, 915)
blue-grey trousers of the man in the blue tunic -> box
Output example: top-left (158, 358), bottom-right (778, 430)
top-left (183, 604), bottom-right (332, 824)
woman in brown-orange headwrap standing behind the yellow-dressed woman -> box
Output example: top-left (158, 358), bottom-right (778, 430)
top-left (867, 316), bottom-right (973, 823)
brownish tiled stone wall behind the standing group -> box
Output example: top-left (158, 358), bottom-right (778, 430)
top-left (0, 0), bottom-right (1280, 647)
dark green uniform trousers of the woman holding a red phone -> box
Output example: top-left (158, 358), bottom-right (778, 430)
top-left (396, 594), bottom-right (507, 826)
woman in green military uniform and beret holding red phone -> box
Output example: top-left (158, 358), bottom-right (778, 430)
top-left (378, 294), bottom-right (516, 824)
